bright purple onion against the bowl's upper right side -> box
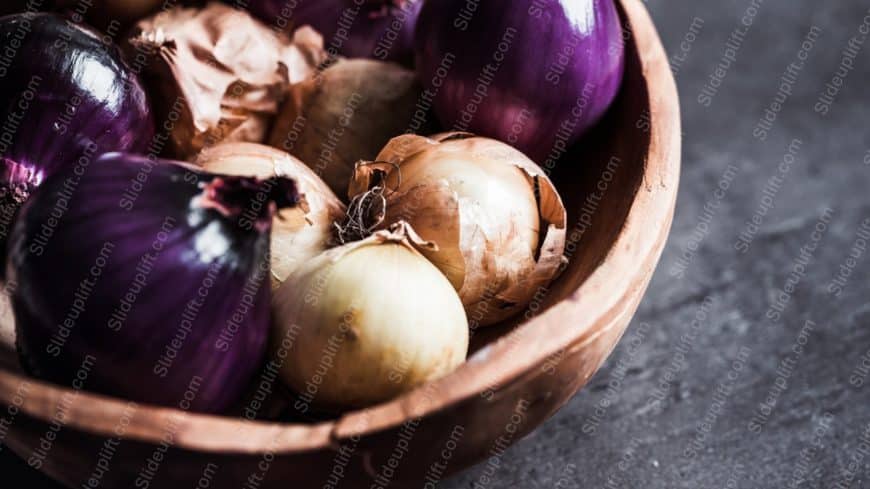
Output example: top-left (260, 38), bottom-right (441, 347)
top-left (415, 0), bottom-right (624, 164)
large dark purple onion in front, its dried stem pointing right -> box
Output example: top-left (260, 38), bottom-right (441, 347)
top-left (7, 154), bottom-right (298, 412)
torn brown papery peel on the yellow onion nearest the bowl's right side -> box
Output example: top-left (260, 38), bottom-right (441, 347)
top-left (349, 132), bottom-right (567, 326)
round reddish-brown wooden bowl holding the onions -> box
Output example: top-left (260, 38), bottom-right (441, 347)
top-left (0, 0), bottom-right (680, 489)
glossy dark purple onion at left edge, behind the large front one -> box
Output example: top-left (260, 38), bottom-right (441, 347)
top-left (0, 13), bottom-right (154, 194)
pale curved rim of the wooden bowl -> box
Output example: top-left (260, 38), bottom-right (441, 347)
top-left (0, 0), bottom-right (680, 455)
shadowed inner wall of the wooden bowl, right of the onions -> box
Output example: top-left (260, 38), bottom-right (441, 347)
top-left (270, 6), bottom-right (651, 422)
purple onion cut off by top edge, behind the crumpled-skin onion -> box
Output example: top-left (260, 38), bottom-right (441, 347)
top-left (240, 0), bottom-right (423, 65)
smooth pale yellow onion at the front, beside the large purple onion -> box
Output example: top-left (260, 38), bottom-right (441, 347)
top-left (273, 223), bottom-right (468, 412)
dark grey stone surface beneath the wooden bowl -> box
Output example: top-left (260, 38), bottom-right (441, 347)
top-left (0, 0), bottom-right (870, 489)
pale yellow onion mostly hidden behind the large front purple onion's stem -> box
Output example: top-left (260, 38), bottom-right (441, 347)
top-left (196, 143), bottom-right (346, 290)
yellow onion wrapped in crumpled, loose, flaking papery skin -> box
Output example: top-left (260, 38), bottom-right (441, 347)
top-left (127, 2), bottom-right (326, 159)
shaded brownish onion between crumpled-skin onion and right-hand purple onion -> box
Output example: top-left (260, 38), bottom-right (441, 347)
top-left (269, 59), bottom-right (427, 195)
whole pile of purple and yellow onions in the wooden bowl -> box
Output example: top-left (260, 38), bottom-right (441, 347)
top-left (0, 0), bottom-right (624, 413)
